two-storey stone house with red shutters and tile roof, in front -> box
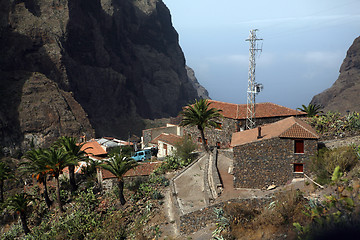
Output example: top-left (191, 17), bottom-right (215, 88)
top-left (231, 117), bottom-right (319, 188)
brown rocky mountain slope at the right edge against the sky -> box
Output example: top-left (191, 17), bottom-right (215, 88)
top-left (311, 37), bottom-right (360, 113)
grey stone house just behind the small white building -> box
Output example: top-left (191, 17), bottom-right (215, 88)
top-left (141, 123), bottom-right (184, 148)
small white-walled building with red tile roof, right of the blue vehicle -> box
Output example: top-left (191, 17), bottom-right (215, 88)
top-left (150, 133), bottom-right (182, 158)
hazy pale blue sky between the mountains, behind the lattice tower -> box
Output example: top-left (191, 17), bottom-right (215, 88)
top-left (163, 0), bottom-right (360, 108)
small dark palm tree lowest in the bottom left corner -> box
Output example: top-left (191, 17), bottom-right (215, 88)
top-left (6, 193), bottom-right (33, 235)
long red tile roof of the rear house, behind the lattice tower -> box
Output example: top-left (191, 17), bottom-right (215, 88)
top-left (208, 100), bottom-right (306, 119)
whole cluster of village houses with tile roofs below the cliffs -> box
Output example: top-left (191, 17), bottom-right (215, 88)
top-left (76, 100), bottom-right (319, 189)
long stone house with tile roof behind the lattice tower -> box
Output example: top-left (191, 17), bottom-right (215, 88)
top-left (184, 100), bottom-right (306, 148)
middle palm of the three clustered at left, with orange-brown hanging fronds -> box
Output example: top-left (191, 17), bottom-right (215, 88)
top-left (44, 148), bottom-right (75, 212)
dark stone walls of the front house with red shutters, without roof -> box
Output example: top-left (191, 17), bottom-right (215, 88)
top-left (234, 138), bottom-right (317, 188)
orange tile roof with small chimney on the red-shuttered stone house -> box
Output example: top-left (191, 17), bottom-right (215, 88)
top-left (231, 117), bottom-right (319, 146)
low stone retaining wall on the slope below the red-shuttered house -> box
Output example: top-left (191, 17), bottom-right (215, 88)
top-left (180, 197), bottom-right (272, 235)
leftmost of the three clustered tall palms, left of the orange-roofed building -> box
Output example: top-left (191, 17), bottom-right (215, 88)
top-left (20, 148), bottom-right (52, 208)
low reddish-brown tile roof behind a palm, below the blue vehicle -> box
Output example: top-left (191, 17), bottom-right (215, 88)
top-left (100, 162), bottom-right (162, 179)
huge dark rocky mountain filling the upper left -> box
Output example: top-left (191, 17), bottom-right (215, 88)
top-left (0, 0), bottom-right (206, 152)
